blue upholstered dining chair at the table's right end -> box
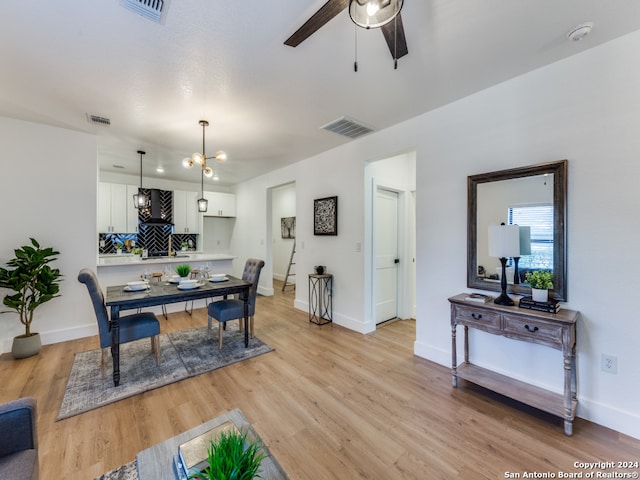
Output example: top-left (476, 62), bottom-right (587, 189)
top-left (207, 258), bottom-right (264, 348)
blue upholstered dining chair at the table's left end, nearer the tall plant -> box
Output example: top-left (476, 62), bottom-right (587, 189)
top-left (78, 268), bottom-right (160, 377)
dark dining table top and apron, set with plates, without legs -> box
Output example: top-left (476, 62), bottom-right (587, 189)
top-left (105, 275), bottom-right (251, 310)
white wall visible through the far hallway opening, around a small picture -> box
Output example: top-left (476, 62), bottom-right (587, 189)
top-left (271, 183), bottom-right (296, 282)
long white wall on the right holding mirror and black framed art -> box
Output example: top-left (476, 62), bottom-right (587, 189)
top-left (234, 33), bottom-right (640, 438)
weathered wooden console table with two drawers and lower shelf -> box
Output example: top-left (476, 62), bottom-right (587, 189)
top-left (449, 294), bottom-right (580, 435)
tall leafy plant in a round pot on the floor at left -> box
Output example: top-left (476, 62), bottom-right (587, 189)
top-left (0, 238), bottom-right (62, 358)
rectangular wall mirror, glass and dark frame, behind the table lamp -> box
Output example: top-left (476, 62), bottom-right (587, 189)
top-left (467, 160), bottom-right (567, 301)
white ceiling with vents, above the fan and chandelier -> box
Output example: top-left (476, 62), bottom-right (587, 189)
top-left (0, 0), bottom-right (640, 185)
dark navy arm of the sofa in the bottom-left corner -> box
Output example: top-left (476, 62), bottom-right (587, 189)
top-left (0, 397), bottom-right (38, 456)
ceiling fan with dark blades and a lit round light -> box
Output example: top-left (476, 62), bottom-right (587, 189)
top-left (284, 0), bottom-right (409, 70)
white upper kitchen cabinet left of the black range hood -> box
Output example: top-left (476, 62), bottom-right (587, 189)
top-left (98, 182), bottom-right (138, 233)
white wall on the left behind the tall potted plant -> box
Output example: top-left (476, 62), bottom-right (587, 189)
top-left (0, 117), bottom-right (98, 353)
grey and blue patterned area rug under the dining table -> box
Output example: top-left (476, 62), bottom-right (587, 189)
top-left (57, 322), bottom-right (273, 420)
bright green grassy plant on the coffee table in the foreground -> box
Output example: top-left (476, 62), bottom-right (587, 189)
top-left (189, 431), bottom-right (265, 480)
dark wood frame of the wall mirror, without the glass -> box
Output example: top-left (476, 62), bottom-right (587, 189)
top-left (467, 160), bottom-right (568, 301)
